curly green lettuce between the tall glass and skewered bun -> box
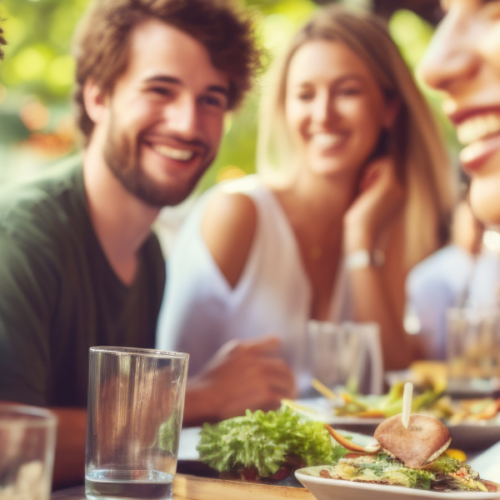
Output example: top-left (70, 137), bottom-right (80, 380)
top-left (197, 407), bottom-right (338, 477)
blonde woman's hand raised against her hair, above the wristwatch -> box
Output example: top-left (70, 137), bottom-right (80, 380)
top-left (344, 156), bottom-right (405, 254)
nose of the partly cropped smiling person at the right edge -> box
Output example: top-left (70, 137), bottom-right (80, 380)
top-left (418, 12), bottom-right (478, 92)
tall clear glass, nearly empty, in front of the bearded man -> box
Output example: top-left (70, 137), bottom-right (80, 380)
top-left (85, 347), bottom-right (189, 499)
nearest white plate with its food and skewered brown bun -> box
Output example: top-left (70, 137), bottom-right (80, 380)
top-left (295, 388), bottom-right (500, 500)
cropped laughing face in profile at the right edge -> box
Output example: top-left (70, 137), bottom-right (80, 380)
top-left (421, 0), bottom-right (500, 223)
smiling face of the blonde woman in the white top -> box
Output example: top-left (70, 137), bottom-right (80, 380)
top-left (285, 40), bottom-right (396, 177)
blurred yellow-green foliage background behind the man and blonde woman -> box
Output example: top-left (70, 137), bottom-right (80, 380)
top-left (0, 0), bottom-right (454, 190)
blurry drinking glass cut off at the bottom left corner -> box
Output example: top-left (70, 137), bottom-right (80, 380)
top-left (0, 403), bottom-right (57, 500)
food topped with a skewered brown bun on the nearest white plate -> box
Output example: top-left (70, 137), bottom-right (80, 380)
top-left (320, 415), bottom-right (500, 492)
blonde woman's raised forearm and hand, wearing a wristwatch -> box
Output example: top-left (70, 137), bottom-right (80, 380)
top-left (344, 157), bottom-right (413, 370)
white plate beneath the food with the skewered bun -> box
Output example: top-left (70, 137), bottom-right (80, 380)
top-left (295, 466), bottom-right (500, 500)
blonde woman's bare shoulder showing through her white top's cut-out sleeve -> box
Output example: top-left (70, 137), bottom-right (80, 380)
top-left (201, 192), bottom-right (257, 288)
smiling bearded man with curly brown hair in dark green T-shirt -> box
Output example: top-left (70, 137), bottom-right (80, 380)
top-left (0, 0), bottom-right (258, 486)
